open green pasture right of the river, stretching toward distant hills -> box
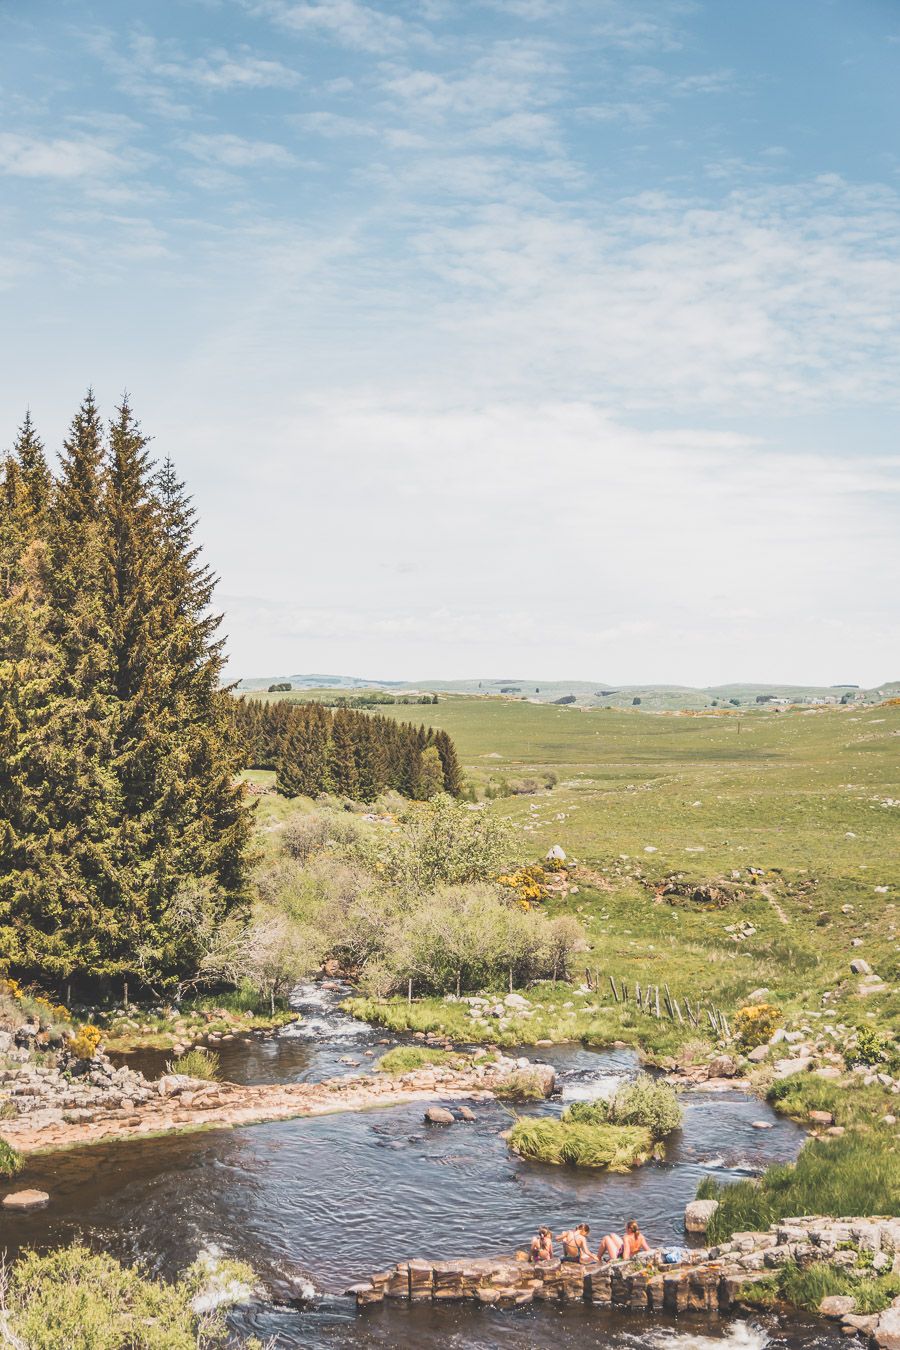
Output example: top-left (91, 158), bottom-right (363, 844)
top-left (248, 695), bottom-right (900, 1025)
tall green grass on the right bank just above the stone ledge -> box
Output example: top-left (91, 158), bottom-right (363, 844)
top-left (698, 1129), bottom-right (900, 1243)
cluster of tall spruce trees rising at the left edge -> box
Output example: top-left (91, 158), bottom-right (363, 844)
top-left (0, 393), bottom-right (251, 987)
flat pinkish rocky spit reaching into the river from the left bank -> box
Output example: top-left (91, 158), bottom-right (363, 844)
top-left (0, 1050), bottom-right (555, 1153)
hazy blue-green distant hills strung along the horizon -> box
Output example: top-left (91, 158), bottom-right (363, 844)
top-left (237, 675), bottom-right (900, 711)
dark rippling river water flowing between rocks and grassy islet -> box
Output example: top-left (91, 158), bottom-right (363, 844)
top-left (0, 986), bottom-right (843, 1350)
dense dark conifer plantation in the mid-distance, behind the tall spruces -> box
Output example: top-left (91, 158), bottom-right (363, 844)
top-left (232, 698), bottom-right (463, 802)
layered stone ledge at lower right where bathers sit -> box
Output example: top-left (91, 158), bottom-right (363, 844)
top-left (347, 1215), bottom-right (900, 1350)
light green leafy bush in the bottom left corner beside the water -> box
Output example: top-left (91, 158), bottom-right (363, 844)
top-left (4, 1246), bottom-right (236, 1350)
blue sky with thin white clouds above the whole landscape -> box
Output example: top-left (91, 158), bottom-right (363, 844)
top-left (0, 0), bottom-right (900, 684)
